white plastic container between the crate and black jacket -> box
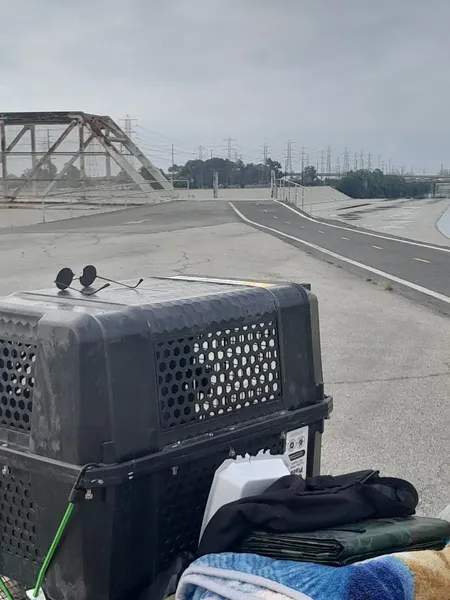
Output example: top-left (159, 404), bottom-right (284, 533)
top-left (200, 451), bottom-right (290, 539)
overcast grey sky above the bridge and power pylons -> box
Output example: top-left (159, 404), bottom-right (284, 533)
top-left (0, 0), bottom-right (450, 172)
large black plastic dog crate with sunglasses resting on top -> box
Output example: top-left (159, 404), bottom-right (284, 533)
top-left (0, 278), bottom-right (331, 600)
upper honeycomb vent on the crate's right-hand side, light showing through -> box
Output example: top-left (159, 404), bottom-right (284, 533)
top-left (156, 316), bottom-right (282, 431)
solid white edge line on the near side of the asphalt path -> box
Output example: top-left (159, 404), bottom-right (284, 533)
top-left (229, 202), bottom-right (450, 304)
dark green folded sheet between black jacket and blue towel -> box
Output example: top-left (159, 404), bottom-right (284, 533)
top-left (236, 517), bottom-right (450, 566)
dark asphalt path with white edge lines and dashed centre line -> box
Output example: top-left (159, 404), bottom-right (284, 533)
top-left (231, 201), bottom-right (450, 313)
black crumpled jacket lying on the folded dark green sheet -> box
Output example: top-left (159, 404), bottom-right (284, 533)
top-left (198, 471), bottom-right (418, 556)
